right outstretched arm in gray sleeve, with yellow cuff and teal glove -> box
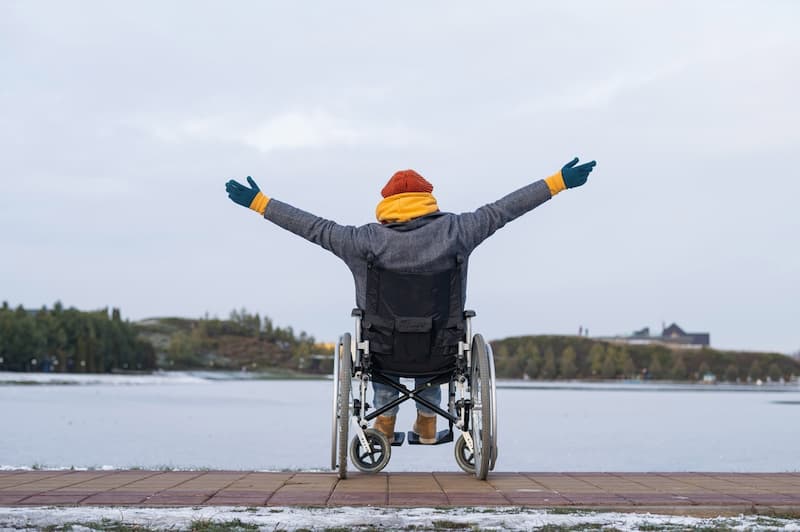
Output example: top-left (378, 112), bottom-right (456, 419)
top-left (458, 157), bottom-right (597, 250)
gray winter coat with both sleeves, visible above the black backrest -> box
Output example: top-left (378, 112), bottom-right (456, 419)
top-left (264, 180), bottom-right (551, 309)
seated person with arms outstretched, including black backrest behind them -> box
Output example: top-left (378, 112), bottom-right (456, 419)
top-left (225, 158), bottom-right (596, 474)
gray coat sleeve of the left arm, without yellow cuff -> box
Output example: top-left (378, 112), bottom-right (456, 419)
top-left (264, 198), bottom-right (363, 262)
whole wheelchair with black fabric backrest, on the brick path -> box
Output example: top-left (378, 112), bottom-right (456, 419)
top-left (331, 258), bottom-right (497, 480)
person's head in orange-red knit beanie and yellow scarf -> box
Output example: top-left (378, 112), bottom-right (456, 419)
top-left (375, 170), bottom-right (439, 223)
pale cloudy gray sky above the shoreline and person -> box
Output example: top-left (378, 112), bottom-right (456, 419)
top-left (0, 0), bottom-right (800, 353)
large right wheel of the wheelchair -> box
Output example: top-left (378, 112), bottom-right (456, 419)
top-left (470, 334), bottom-right (494, 480)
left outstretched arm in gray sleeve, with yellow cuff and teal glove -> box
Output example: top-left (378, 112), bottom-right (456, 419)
top-left (225, 176), bottom-right (358, 258)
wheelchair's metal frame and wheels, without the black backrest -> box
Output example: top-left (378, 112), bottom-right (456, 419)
top-left (331, 309), bottom-right (497, 480)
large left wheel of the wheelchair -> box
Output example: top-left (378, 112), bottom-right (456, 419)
top-left (331, 333), bottom-right (353, 479)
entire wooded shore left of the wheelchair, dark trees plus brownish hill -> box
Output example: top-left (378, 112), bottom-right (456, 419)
top-left (0, 302), bottom-right (317, 373)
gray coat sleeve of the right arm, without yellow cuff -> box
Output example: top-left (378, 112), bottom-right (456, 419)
top-left (456, 179), bottom-right (552, 251)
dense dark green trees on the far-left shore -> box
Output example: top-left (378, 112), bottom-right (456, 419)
top-left (0, 302), bottom-right (155, 373)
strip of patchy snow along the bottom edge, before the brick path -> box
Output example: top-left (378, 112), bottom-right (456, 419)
top-left (0, 507), bottom-right (800, 531)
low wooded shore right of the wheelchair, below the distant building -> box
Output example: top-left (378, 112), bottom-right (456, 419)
top-left (491, 336), bottom-right (800, 382)
